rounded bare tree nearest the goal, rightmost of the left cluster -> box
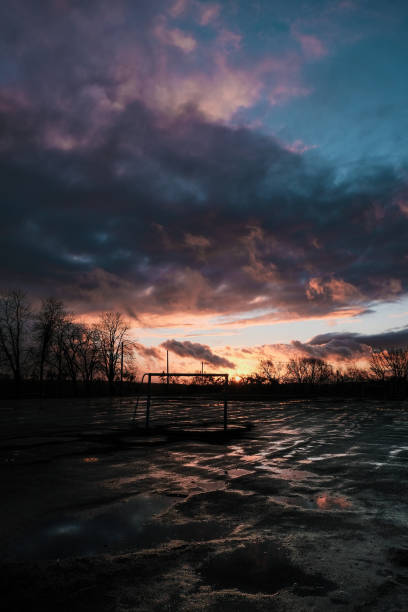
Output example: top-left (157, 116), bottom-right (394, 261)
top-left (95, 312), bottom-right (129, 393)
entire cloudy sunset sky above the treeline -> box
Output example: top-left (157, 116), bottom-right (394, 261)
top-left (0, 0), bottom-right (408, 373)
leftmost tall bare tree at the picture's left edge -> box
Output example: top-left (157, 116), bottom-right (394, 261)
top-left (0, 290), bottom-right (31, 394)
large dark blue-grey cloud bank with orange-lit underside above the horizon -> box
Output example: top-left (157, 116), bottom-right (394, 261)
top-left (0, 89), bottom-right (408, 323)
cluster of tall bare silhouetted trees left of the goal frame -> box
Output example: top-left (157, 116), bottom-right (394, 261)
top-left (0, 290), bottom-right (136, 395)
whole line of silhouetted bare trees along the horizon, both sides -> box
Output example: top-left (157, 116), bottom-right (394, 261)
top-left (0, 290), bottom-right (408, 395)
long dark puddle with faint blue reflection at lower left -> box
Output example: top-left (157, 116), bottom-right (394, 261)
top-left (15, 495), bottom-right (174, 560)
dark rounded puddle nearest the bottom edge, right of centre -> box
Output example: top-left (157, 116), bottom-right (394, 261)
top-left (201, 541), bottom-right (336, 595)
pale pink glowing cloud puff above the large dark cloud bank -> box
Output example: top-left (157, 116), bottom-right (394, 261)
top-left (110, 41), bottom-right (264, 121)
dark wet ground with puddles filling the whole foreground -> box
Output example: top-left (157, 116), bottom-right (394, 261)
top-left (0, 398), bottom-right (408, 612)
